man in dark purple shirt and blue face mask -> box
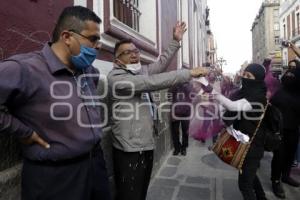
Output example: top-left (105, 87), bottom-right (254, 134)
top-left (0, 6), bottom-right (111, 200)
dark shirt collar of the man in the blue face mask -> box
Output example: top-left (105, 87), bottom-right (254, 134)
top-left (42, 42), bottom-right (67, 74)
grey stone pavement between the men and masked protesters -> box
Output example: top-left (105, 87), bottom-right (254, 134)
top-left (147, 139), bottom-right (300, 200)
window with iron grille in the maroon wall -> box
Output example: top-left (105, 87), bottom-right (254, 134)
top-left (114, 0), bottom-right (142, 31)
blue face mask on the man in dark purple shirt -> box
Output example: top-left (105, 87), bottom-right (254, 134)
top-left (71, 45), bottom-right (97, 70)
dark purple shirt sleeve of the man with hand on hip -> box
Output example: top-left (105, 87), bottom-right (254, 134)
top-left (0, 61), bottom-right (33, 138)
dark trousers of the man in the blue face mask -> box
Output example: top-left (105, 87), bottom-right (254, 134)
top-left (22, 148), bottom-right (111, 200)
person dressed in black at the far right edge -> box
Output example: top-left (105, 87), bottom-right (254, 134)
top-left (271, 60), bottom-right (300, 198)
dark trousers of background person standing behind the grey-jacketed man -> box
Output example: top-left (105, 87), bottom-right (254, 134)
top-left (172, 120), bottom-right (190, 151)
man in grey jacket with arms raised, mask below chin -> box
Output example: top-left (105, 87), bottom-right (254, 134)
top-left (108, 22), bottom-right (207, 200)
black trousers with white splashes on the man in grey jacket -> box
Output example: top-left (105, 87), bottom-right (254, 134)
top-left (113, 148), bottom-right (153, 200)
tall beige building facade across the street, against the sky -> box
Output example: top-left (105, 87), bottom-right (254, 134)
top-left (251, 0), bottom-right (281, 70)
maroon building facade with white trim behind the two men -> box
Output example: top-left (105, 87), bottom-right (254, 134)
top-left (0, 0), bottom-right (208, 200)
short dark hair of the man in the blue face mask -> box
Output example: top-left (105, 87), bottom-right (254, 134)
top-left (52, 6), bottom-right (102, 42)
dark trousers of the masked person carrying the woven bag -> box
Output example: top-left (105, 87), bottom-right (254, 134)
top-left (238, 148), bottom-right (266, 200)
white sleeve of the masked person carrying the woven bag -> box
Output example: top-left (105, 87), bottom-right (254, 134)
top-left (216, 94), bottom-right (252, 111)
